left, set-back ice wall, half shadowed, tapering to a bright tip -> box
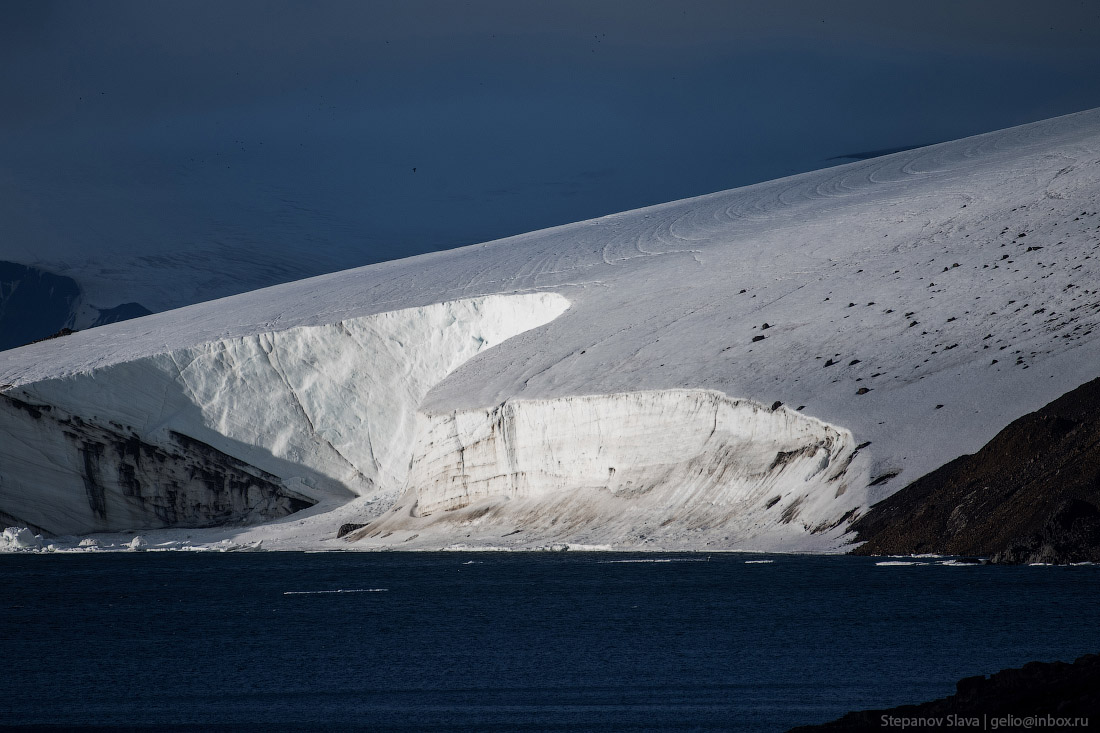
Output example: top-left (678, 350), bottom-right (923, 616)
top-left (0, 294), bottom-right (569, 534)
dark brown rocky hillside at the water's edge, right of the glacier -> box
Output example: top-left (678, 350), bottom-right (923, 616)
top-left (853, 380), bottom-right (1100, 562)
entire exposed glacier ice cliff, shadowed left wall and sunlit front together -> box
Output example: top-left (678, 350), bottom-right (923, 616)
top-left (0, 294), bottom-right (867, 549)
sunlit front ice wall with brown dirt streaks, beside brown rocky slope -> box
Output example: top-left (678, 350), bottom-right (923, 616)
top-left (351, 390), bottom-right (867, 549)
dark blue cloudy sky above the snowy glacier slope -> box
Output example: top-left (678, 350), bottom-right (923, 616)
top-left (0, 0), bottom-right (1100, 305)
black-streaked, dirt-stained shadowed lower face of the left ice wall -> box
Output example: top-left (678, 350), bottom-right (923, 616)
top-left (0, 394), bottom-right (316, 534)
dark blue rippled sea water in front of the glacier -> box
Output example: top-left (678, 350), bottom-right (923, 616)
top-left (0, 553), bottom-right (1100, 732)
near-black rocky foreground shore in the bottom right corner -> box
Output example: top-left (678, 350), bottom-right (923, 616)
top-left (790, 654), bottom-right (1100, 733)
